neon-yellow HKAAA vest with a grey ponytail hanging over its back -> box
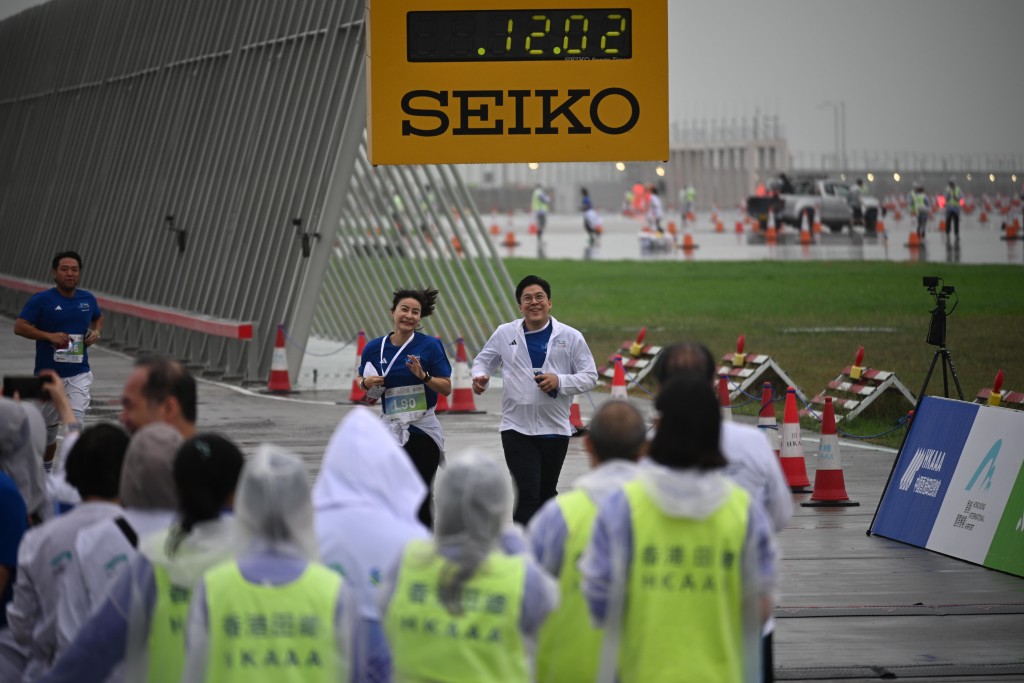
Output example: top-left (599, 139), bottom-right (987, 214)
top-left (384, 541), bottom-right (529, 683)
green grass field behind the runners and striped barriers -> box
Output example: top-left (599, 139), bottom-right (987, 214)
top-left (505, 259), bottom-right (1024, 444)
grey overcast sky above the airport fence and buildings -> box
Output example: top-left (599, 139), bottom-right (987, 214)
top-left (0, 0), bottom-right (1024, 155)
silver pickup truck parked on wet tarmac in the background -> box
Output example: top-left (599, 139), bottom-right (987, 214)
top-left (746, 178), bottom-right (882, 234)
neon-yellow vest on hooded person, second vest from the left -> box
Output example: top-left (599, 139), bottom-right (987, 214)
top-left (204, 560), bottom-right (347, 683)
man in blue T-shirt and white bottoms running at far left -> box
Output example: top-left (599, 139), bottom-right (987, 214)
top-left (14, 251), bottom-right (103, 470)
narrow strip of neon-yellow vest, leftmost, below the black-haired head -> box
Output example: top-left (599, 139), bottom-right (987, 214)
top-left (145, 564), bottom-right (191, 683)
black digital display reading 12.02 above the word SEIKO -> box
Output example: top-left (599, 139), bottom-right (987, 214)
top-left (406, 8), bottom-right (633, 61)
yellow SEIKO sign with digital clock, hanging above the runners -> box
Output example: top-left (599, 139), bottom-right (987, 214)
top-left (367, 0), bottom-right (669, 164)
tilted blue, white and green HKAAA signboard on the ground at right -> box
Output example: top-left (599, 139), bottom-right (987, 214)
top-left (870, 396), bottom-right (1024, 577)
